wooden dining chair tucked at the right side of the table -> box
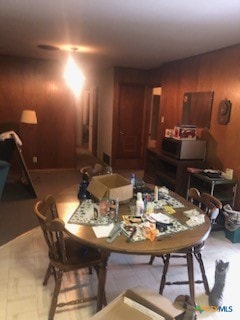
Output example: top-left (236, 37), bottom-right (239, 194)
top-left (149, 188), bottom-right (222, 300)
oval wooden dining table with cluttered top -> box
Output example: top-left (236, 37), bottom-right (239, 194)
top-left (58, 192), bottom-right (211, 310)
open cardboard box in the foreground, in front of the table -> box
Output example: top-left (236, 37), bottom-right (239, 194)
top-left (90, 287), bottom-right (184, 320)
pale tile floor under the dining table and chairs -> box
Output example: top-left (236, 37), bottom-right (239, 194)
top-left (0, 227), bottom-right (240, 320)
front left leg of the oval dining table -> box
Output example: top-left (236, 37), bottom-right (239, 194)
top-left (97, 250), bottom-right (110, 312)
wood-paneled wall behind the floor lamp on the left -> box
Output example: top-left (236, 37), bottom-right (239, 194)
top-left (0, 56), bottom-right (76, 169)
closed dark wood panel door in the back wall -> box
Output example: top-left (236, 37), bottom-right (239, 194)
top-left (115, 84), bottom-right (145, 168)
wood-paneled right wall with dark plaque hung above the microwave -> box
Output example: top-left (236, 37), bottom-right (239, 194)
top-left (159, 45), bottom-right (240, 209)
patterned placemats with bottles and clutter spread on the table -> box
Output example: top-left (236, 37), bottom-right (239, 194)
top-left (69, 182), bottom-right (201, 242)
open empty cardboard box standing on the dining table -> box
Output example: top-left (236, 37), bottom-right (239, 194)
top-left (87, 173), bottom-right (133, 202)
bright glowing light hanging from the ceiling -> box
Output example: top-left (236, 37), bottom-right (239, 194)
top-left (63, 55), bottom-right (85, 97)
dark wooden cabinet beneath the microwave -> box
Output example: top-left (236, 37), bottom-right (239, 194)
top-left (144, 149), bottom-right (204, 198)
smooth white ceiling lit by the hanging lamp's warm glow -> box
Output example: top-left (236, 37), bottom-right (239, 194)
top-left (0, 0), bottom-right (240, 74)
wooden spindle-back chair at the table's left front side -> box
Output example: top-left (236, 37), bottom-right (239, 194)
top-left (34, 196), bottom-right (106, 320)
